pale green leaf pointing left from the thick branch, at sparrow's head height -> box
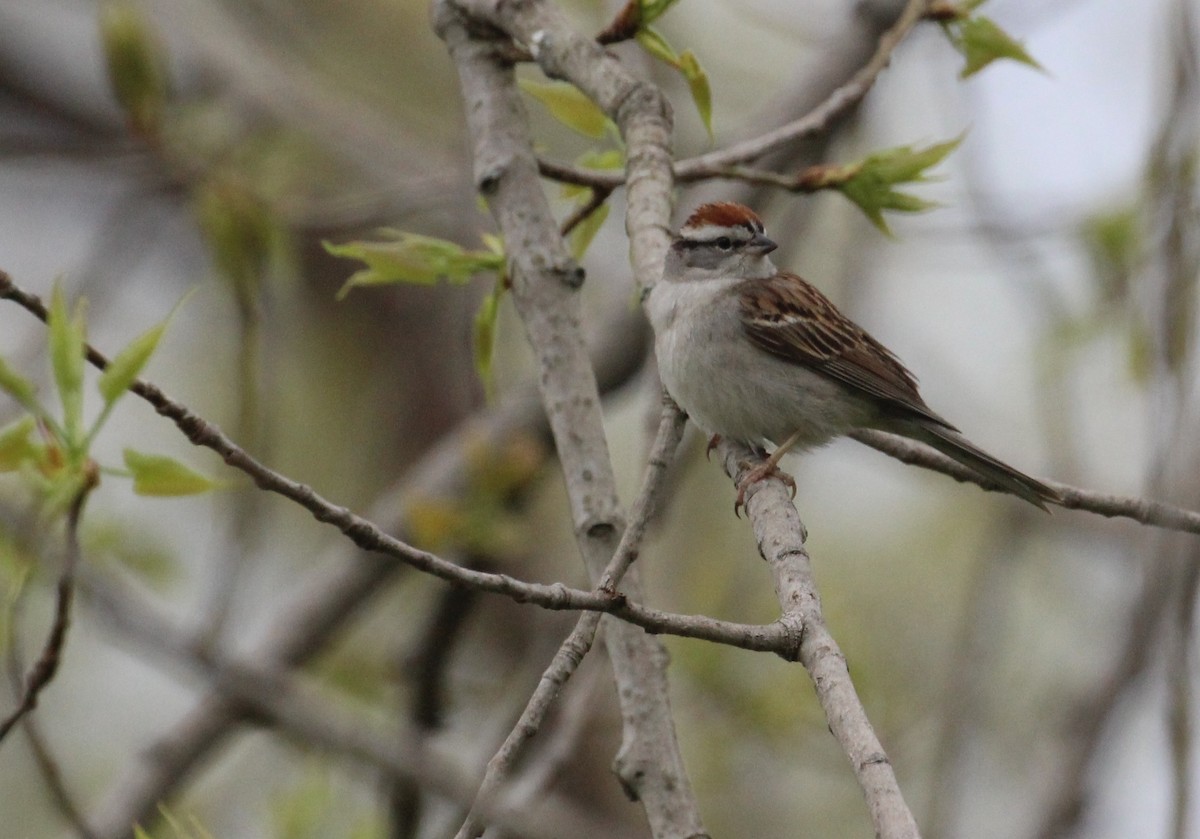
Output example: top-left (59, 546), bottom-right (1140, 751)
top-left (324, 230), bottom-right (505, 300)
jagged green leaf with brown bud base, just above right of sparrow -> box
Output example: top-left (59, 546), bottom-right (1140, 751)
top-left (800, 137), bottom-right (962, 235)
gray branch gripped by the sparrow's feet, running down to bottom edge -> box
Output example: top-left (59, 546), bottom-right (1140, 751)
top-left (718, 441), bottom-right (920, 839)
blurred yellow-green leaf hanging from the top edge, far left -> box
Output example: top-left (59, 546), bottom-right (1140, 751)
top-left (100, 0), bottom-right (167, 136)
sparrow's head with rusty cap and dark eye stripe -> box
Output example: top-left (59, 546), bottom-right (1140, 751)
top-left (665, 202), bottom-right (778, 281)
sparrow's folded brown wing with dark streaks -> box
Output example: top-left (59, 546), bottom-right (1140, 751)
top-left (738, 271), bottom-right (954, 429)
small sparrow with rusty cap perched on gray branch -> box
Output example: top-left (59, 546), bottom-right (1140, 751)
top-left (648, 203), bottom-right (1060, 513)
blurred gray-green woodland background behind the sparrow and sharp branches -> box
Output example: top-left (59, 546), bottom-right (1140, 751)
top-left (0, 0), bottom-right (1200, 839)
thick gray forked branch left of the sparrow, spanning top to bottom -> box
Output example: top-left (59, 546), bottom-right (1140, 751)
top-left (434, 0), bottom-right (704, 837)
